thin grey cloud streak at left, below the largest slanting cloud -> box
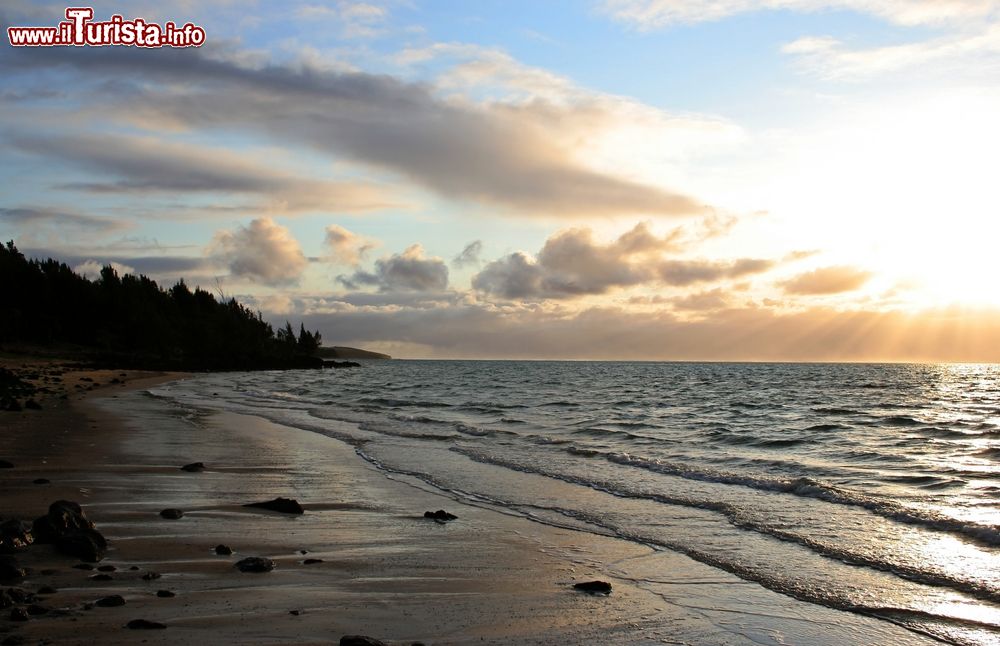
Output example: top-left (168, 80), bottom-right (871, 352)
top-left (7, 134), bottom-right (392, 212)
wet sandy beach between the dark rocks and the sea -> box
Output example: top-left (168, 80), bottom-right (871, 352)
top-left (0, 368), bottom-right (930, 644)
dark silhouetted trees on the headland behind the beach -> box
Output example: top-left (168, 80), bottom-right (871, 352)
top-left (0, 242), bottom-right (323, 370)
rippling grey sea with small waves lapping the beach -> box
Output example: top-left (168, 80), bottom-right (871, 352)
top-left (147, 360), bottom-right (1000, 644)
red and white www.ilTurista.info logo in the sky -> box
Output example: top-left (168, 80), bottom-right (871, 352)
top-left (7, 7), bottom-right (205, 47)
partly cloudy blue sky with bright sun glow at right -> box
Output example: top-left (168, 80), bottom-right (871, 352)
top-left (0, 0), bottom-right (1000, 362)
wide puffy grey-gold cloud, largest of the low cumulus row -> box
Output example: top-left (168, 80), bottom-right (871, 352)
top-left (472, 222), bottom-right (775, 299)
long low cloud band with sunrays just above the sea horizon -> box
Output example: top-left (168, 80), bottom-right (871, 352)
top-left (294, 303), bottom-right (1000, 361)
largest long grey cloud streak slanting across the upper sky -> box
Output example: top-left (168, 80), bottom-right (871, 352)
top-left (0, 48), bottom-right (704, 217)
